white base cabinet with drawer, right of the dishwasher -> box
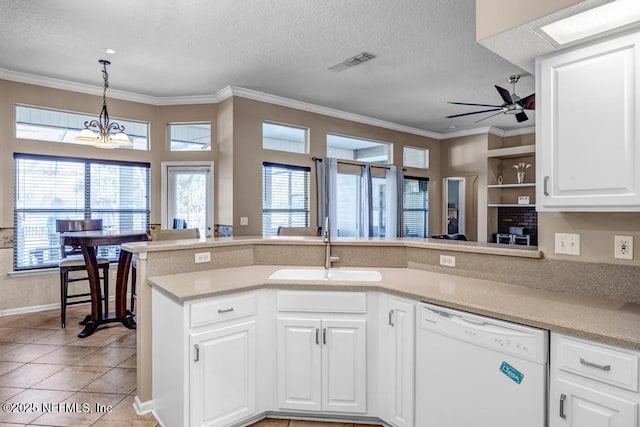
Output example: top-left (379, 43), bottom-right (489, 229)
top-left (549, 333), bottom-right (640, 427)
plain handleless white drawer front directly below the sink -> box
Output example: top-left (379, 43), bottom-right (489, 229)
top-left (278, 291), bottom-right (367, 313)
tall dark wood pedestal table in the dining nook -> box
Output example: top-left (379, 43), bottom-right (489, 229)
top-left (60, 230), bottom-right (147, 338)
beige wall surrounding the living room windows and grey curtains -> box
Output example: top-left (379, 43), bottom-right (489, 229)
top-left (233, 98), bottom-right (440, 236)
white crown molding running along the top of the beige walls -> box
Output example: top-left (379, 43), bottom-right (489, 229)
top-left (0, 68), bottom-right (535, 140)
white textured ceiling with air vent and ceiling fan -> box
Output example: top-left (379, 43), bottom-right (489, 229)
top-left (0, 0), bottom-right (535, 133)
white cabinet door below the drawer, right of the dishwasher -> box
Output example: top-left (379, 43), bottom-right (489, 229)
top-left (549, 379), bottom-right (638, 427)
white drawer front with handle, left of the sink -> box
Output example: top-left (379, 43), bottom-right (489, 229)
top-left (191, 294), bottom-right (257, 328)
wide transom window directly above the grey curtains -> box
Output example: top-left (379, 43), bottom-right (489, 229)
top-left (327, 133), bottom-right (393, 164)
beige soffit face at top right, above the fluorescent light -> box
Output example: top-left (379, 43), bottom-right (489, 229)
top-left (476, 0), bottom-right (584, 40)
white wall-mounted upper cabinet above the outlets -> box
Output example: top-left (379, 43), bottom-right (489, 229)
top-left (536, 30), bottom-right (640, 211)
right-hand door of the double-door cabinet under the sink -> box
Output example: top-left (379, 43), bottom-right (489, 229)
top-left (322, 319), bottom-right (367, 413)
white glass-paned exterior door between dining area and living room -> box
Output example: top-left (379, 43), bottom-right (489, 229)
top-left (162, 162), bottom-right (213, 237)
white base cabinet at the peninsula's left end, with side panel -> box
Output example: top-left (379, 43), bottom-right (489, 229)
top-left (152, 288), bottom-right (259, 427)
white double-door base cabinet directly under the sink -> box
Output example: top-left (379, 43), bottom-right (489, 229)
top-left (277, 291), bottom-right (367, 413)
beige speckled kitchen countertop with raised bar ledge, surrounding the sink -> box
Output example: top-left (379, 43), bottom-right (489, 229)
top-left (122, 237), bottom-right (640, 412)
